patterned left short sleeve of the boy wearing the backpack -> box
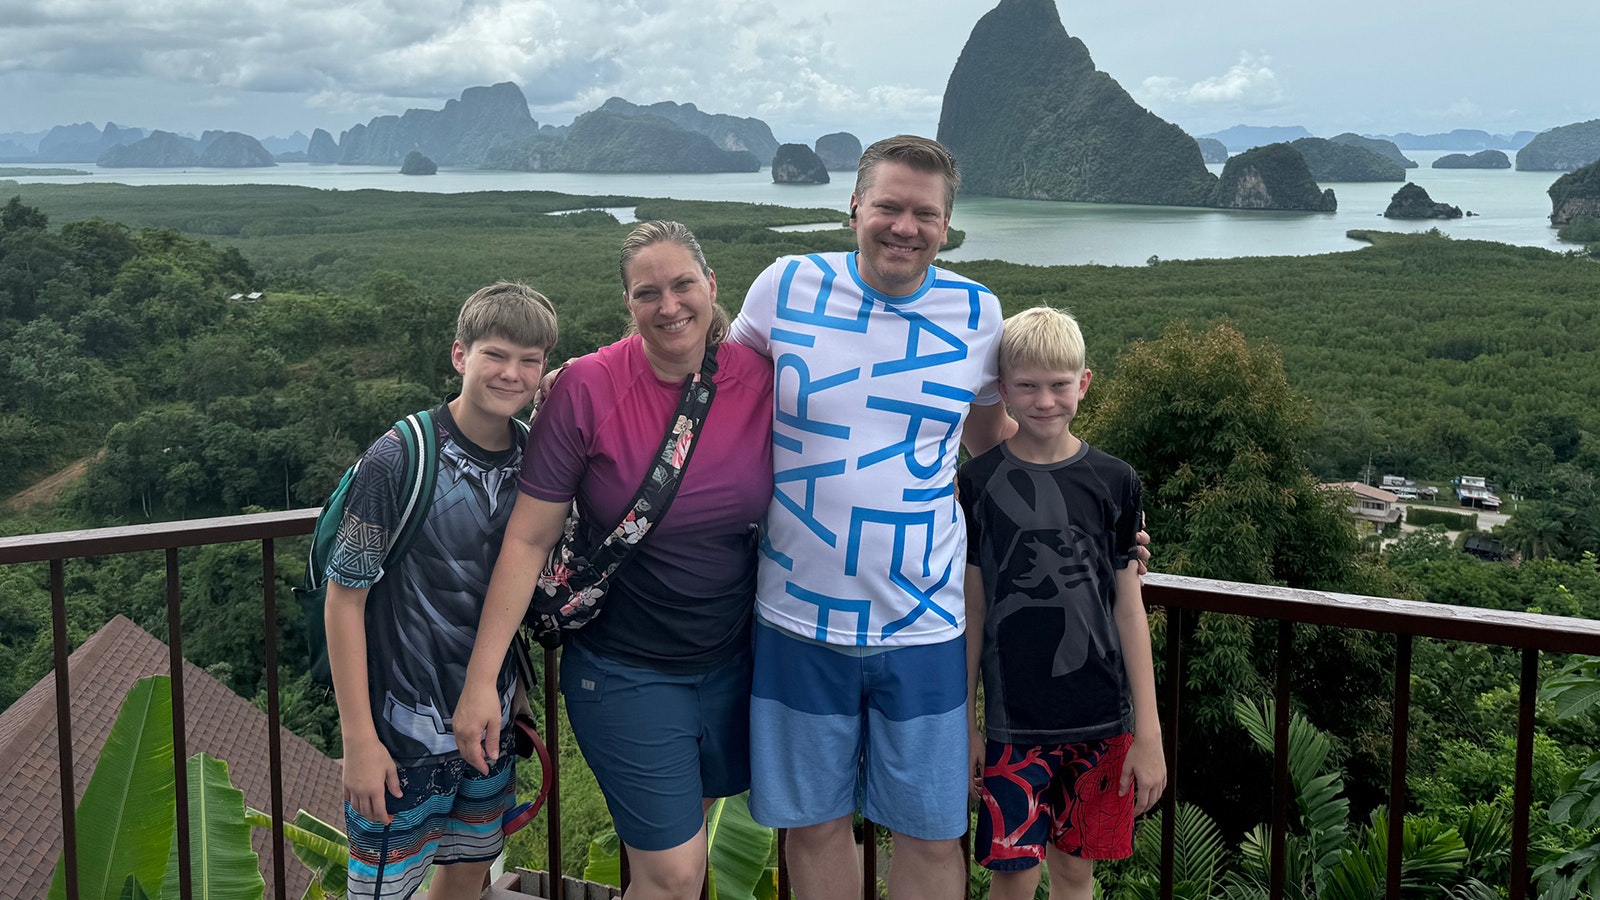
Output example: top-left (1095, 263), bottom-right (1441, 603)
top-left (328, 431), bottom-right (405, 588)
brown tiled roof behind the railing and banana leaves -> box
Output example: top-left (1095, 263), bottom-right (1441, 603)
top-left (0, 615), bottom-right (344, 898)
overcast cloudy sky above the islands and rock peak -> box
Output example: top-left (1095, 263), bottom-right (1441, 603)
top-left (0, 0), bottom-right (1600, 143)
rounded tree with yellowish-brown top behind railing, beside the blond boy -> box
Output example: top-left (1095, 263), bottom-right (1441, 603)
top-left (1082, 322), bottom-right (1392, 831)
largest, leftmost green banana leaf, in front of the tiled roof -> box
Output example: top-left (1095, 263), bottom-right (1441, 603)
top-left (48, 676), bottom-right (178, 900)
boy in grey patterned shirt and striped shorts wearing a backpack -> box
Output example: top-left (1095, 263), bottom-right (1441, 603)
top-left (325, 282), bottom-right (557, 900)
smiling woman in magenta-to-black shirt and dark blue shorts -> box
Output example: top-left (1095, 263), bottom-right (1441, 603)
top-left (454, 221), bottom-right (773, 900)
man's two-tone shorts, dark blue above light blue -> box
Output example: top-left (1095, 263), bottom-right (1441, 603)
top-left (750, 620), bottom-right (966, 841)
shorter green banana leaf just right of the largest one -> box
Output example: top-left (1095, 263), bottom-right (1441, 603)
top-left (162, 753), bottom-right (267, 900)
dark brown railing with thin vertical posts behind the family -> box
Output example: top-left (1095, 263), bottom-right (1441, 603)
top-left (0, 509), bottom-right (1600, 900)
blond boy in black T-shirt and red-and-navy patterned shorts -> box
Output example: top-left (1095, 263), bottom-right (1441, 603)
top-left (957, 307), bottom-right (1166, 900)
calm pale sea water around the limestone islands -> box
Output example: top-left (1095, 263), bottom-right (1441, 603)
top-left (3, 151), bottom-right (1574, 266)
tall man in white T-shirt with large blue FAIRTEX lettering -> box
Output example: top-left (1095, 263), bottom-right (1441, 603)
top-left (733, 135), bottom-right (1016, 900)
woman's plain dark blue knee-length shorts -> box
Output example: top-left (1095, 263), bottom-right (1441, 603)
top-left (562, 642), bottom-right (750, 850)
